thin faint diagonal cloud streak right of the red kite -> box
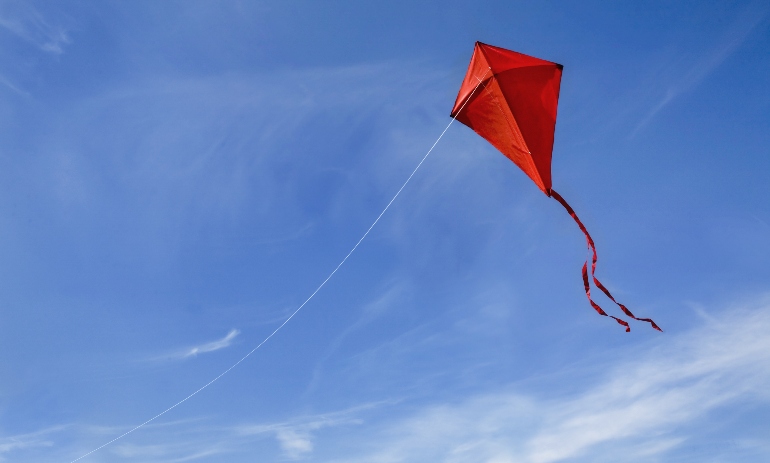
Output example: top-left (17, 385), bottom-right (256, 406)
top-left (630, 4), bottom-right (768, 137)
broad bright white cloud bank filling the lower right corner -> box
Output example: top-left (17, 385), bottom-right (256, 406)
top-left (334, 298), bottom-right (770, 463)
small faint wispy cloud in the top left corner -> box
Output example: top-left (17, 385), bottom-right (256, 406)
top-left (0, 1), bottom-right (71, 55)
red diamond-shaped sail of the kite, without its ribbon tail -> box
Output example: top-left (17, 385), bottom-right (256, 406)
top-left (451, 42), bottom-right (562, 196)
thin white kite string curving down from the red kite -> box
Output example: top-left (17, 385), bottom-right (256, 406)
top-left (70, 68), bottom-right (492, 463)
